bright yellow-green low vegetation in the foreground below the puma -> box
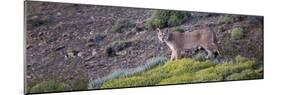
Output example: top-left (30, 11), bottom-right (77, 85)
top-left (102, 56), bottom-right (263, 88)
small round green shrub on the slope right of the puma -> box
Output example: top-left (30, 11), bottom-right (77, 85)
top-left (231, 28), bottom-right (244, 40)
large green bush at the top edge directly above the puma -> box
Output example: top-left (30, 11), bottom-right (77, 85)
top-left (146, 10), bottom-right (190, 29)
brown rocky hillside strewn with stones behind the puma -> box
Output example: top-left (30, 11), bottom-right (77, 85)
top-left (26, 1), bottom-right (263, 93)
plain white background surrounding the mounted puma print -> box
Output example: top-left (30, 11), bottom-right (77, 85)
top-left (0, 0), bottom-right (281, 95)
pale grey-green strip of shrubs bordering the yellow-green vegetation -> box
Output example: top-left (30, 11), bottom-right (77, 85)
top-left (88, 57), bottom-right (167, 89)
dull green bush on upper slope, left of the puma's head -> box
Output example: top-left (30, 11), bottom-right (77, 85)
top-left (111, 19), bottom-right (135, 33)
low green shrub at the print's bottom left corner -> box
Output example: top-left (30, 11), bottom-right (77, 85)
top-left (30, 81), bottom-right (71, 93)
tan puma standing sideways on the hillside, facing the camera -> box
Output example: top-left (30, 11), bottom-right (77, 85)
top-left (157, 28), bottom-right (219, 60)
